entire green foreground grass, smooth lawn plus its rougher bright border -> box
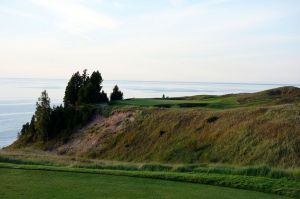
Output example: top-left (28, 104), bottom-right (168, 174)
top-left (0, 163), bottom-right (300, 198)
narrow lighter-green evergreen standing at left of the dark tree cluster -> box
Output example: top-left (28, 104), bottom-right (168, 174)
top-left (34, 91), bottom-right (51, 140)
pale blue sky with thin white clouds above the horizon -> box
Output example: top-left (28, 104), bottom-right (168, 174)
top-left (0, 0), bottom-right (300, 84)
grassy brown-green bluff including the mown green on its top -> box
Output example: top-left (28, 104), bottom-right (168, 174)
top-left (99, 87), bottom-right (300, 167)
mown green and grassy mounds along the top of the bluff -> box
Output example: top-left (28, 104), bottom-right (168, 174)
top-left (112, 87), bottom-right (300, 109)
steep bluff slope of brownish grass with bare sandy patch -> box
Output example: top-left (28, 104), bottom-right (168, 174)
top-left (54, 103), bottom-right (300, 167)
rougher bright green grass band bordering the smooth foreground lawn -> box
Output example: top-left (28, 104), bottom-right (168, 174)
top-left (0, 163), bottom-right (300, 198)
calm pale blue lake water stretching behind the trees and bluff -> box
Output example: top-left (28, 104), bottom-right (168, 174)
top-left (0, 78), bottom-right (299, 148)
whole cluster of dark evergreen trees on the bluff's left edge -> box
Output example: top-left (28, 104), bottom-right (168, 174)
top-left (19, 70), bottom-right (123, 144)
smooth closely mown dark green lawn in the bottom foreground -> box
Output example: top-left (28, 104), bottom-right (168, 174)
top-left (0, 168), bottom-right (287, 199)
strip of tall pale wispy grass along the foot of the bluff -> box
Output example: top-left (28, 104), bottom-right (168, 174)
top-left (0, 154), bottom-right (300, 181)
